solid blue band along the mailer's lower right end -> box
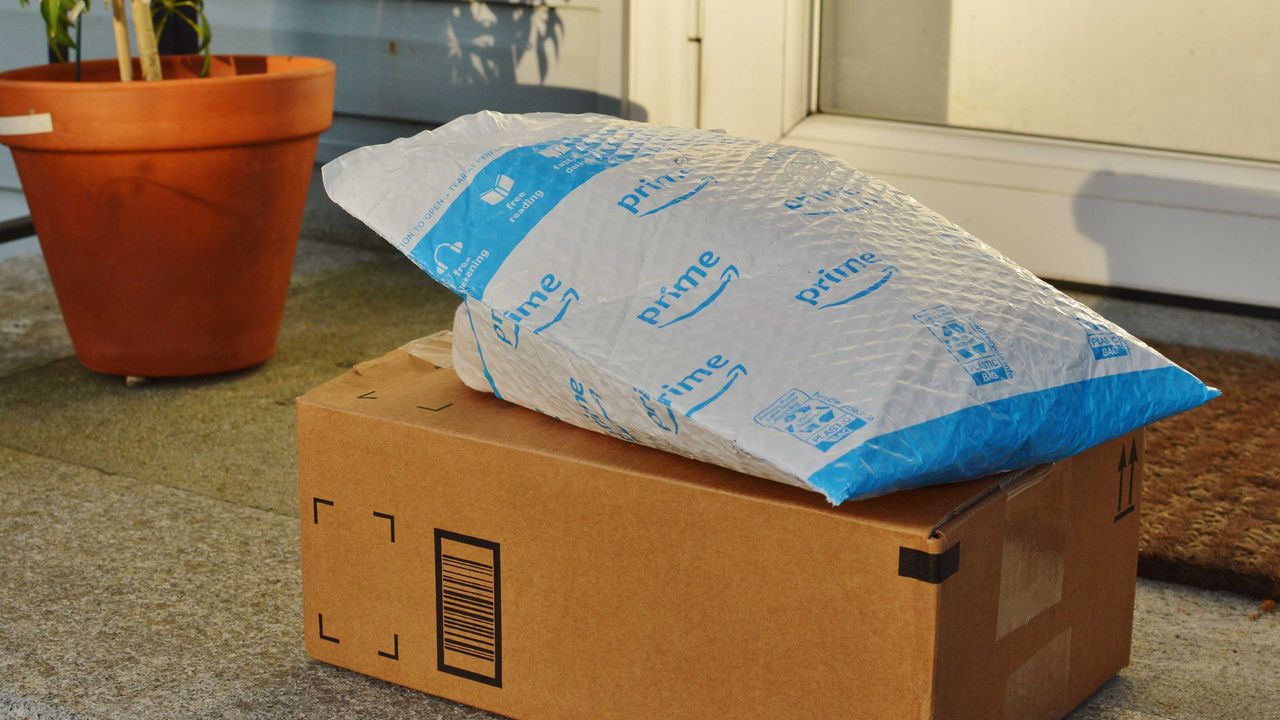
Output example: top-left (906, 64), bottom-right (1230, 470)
top-left (809, 366), bottom-right (1221, 503)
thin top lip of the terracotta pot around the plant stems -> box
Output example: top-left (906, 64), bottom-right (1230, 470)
top-left (0, 53), bottom-right (337, 94)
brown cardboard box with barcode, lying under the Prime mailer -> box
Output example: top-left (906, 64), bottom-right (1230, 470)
top-left (298, 335), bottom-right (1142, 720)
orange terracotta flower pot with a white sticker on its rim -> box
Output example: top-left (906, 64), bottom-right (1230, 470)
top-left (0, 55), bottom-right (334, 377)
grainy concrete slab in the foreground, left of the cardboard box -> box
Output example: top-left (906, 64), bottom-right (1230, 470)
top-left (0, 450), bottom-right (303, 717)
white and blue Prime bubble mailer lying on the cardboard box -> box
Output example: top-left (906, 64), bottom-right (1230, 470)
top-left (324, 113), bottom-right (1217, 503)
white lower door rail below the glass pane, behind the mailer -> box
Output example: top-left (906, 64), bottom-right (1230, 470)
top-left (783, 114), bottom-right (1280, 306)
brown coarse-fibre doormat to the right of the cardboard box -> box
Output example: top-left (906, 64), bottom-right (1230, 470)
top-left (1138, 342), bottom-right (1280, 598)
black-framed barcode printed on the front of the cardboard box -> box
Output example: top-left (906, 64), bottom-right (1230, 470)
top-left (435, 529), bottom-right (502, 688)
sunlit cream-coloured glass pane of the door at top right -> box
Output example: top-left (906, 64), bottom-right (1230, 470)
top-left (819, 0), bottom-right (1280, 160)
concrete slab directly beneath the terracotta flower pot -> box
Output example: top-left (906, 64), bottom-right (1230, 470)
top-left (0, 249), bottom-right (457, 515)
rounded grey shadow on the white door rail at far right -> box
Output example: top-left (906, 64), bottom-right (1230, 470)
top-left (1071, 172), bottom-right (1280, 304)
